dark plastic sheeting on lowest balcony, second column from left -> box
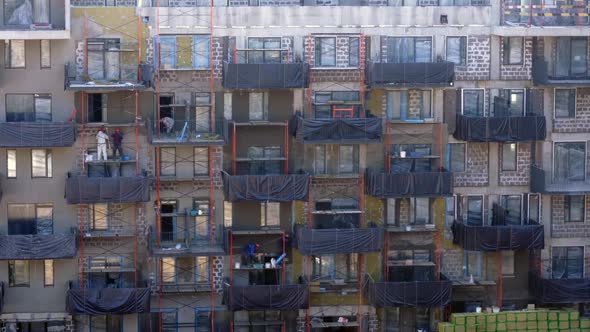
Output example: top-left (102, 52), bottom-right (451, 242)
top-left (66, 288), bottom-right (150, 315)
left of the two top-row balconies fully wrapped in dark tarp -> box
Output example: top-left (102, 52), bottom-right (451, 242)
top-left (223, 49), bottom-right (309, 89)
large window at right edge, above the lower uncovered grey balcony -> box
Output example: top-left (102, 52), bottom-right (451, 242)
top-left (553, 142), bottom-right (586, 181)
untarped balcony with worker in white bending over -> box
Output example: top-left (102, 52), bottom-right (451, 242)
top-left (148, 118), bottom-right (228, 146)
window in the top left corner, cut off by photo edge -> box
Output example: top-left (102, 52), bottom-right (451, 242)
top-left (4, 0), bottom-right (50, 28)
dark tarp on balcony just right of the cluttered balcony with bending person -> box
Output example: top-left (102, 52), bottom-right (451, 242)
top-left (295, 227), bottom-right (383, 256)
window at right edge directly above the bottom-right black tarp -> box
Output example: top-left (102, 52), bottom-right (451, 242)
top-left (551, 247), bottom-right (584, 279)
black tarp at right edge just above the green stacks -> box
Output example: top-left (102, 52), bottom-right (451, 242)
top-left (529, 273), bottom-right (590, 303)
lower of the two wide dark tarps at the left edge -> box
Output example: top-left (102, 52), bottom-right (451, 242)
top-left (0, 233), bottom-right (76, 260)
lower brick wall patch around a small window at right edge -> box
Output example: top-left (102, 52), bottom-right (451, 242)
top-left (551, 195), bottom-right (590, 238)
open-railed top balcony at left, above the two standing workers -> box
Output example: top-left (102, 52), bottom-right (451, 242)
top-left (64, 63), bottom-right (154, 93)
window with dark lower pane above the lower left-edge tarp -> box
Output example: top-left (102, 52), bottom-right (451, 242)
top-left (7, 204), bottom-right (53, 235)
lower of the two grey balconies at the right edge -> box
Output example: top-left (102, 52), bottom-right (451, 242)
top-left (531, 165), bottom-right (590, 195)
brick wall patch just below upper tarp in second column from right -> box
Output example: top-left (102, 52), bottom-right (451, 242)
top-left (453, 143), bottom-right (489, 187)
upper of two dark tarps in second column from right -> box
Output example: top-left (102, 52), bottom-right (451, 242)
top-left (453, 114), bottom-right (546, 142)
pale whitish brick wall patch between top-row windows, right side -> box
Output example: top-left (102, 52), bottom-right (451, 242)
top-left (455, 36), bottom-right (491, 81)
